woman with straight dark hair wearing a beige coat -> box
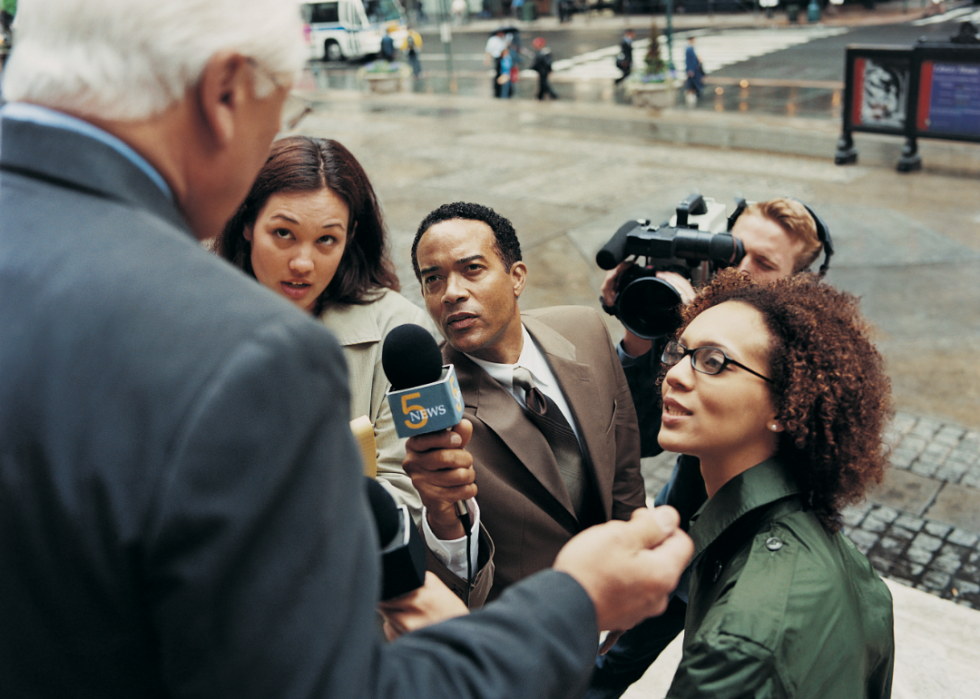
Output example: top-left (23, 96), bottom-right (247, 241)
top-left (217, 136), bottom-right (439, 520)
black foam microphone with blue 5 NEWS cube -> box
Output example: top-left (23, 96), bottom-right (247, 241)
top-left (381, 323), bottom-right (463, 438)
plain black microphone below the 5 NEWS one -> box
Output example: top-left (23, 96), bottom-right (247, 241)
top-left (364, 477), bottom-right (426, 600)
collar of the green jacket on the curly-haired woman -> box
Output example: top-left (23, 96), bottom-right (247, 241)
top-left (690, 457), bottom-right (802, 555)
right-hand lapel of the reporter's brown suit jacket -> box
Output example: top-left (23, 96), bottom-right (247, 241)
top-left (522, 316), bottom-right (615, 519)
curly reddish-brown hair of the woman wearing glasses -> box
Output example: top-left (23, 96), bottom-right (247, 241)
top-left (661, 269), bottom-right (892, 531)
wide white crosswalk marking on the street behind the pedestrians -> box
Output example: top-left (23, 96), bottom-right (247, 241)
top-left (553, 27), bottom-right (848, 80)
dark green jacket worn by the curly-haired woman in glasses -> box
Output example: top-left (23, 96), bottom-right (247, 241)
top-left (667, 459), bottom-right (895, 699)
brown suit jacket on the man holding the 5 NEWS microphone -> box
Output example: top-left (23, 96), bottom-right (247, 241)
top-left (430, 306), bottom-right (645, 602)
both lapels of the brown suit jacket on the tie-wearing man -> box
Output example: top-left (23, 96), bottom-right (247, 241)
top-left (443, 315), bottom-right (615, 520)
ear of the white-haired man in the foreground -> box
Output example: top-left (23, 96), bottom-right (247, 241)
top-left (197, 51), bottom-right (253, 146)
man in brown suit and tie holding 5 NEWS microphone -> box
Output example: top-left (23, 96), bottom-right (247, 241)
top-left (405, 203), bottom-right (645, 606)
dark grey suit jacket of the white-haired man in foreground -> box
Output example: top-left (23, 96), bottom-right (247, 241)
top-left (0, 119), bottom-right (597, 699)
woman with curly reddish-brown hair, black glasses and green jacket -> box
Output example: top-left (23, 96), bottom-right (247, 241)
top-left (660, 270), bottom-right (894, 698)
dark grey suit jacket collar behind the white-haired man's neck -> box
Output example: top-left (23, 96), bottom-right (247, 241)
top-left (0, 113), bottom-right (191, 234)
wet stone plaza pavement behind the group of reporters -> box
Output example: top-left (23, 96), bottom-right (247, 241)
top-left (290, 53), bottom-right (980, 698)
